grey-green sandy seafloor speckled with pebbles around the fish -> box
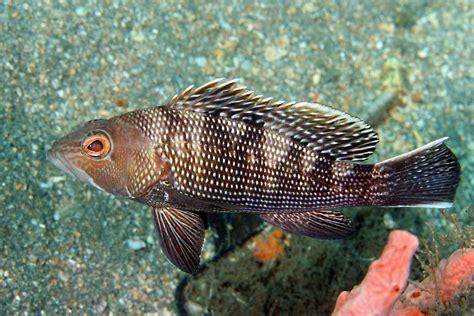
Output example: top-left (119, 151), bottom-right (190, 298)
top-left (0, 0), bottom-right (474, 315)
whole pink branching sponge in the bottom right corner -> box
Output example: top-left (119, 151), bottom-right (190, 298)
top-left (333, 230), bottom-right (474, 316)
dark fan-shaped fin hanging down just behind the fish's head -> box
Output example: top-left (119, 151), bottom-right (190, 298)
top-left (152, 207), bottom-right (204, 273)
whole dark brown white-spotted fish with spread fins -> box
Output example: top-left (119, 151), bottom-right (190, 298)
top-left (47, 79), bottom-right (460, 274)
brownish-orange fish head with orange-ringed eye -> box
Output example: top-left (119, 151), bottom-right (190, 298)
top-left (48, 119), bottom-right (154, 198)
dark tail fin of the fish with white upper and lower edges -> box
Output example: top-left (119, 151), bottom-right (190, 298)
top-left (376, 137), bottom-right (460, 208)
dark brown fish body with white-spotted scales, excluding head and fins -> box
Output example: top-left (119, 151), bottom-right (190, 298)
top-left (117, 108), bottom-right (384, 213)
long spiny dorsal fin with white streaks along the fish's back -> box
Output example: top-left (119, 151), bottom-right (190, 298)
top-left (168, 79), bottom-right (378, 161)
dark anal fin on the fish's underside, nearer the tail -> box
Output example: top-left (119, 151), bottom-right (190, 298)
top-left (260, 211), bottom-right (355, 239)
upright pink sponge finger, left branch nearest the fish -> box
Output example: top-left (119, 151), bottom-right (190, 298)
top-left (333, 230), bottom-right (418, 316)
